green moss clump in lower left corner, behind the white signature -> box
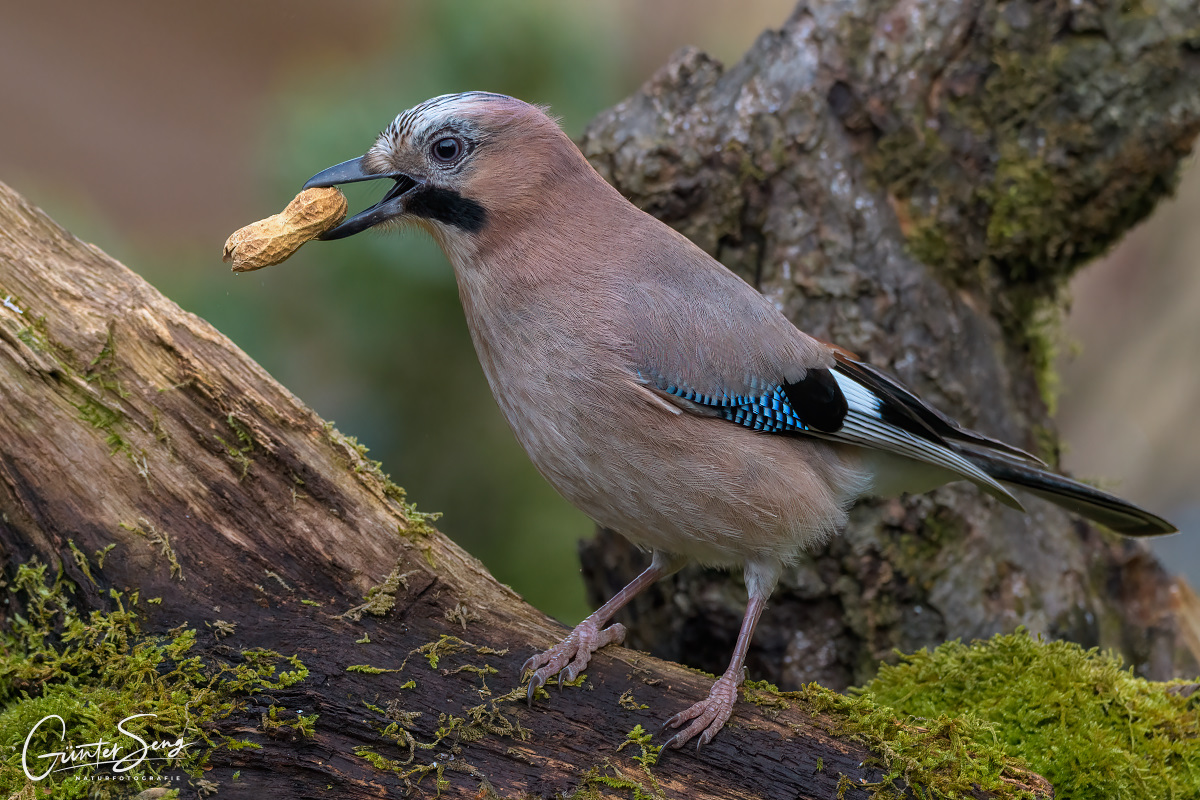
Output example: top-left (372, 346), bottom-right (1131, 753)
top-left (0, 561), bottom-right (316, 798)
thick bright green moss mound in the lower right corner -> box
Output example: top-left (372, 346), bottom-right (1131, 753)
top-left (859, 631), bottom-right (1200, 800)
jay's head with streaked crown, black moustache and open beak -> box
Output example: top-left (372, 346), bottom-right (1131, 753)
top-left (305, 91), bottom-right (592, 249)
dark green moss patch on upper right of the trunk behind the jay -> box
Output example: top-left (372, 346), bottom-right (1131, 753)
top-left (863, 4), bottom-right (1195, 383)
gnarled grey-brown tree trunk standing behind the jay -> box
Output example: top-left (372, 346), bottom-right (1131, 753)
top-left (582, 0), bottom-right (1200, 688)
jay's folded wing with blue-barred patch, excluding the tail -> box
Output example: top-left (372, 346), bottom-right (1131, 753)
top-left (625, 261), bottom-right (1040, 509)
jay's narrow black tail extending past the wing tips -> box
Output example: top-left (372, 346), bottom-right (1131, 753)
top-left (960, 447), bottom-right (1178, 536)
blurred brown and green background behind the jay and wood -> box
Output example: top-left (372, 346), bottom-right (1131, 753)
top-left (0, 0), bottom-right (1200, 622)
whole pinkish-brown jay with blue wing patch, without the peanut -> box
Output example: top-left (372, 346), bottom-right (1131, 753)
top-left (305, 92), bottom-right (1175, 747)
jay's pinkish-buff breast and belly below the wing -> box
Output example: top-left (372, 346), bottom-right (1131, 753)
top-left (460, 284), bottom-right (869, 565)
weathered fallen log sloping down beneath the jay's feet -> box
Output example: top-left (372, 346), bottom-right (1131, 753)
top-left (0, 185), bottom-right (1049, 799)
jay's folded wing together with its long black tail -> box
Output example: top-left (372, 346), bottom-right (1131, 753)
top-left (618, 235), bottom-right (1175, 536)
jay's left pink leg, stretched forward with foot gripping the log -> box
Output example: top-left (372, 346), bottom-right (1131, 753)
top-left (521, 553), bottom-right (682, 703)
